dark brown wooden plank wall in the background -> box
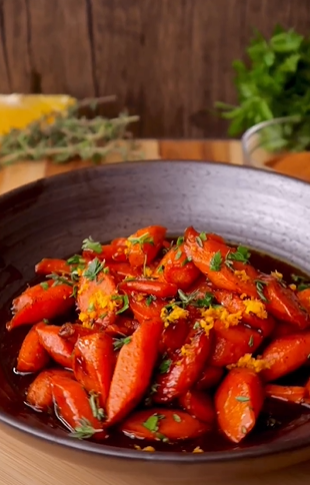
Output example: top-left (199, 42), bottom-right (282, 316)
top-left (0, 0), bottom-right (310, 138)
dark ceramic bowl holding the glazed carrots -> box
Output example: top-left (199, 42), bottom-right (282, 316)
top-left (0, 162), bottom-right (310, 484)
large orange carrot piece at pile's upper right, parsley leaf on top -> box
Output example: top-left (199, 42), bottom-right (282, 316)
top-left (185, 227), bottom-right (258, 298)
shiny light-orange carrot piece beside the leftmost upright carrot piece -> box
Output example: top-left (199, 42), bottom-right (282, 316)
top-left (36, 323), bottom-right (74, 369)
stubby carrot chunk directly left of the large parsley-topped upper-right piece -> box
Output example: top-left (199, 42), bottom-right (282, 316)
top-left (156, 243), bottom-right (201, 290)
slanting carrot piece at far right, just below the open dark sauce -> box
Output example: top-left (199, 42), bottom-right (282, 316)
top-left (261, 276), bottom-right (310, 330)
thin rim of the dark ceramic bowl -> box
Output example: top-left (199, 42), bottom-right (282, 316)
top-left (0, 159), bottom-right (310, 465)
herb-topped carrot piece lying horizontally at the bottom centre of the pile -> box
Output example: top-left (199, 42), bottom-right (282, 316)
top-left (121, 408), bottom-right (209, 442)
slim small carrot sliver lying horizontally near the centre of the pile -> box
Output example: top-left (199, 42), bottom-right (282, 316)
top-left (119, 279), bottom-right (178, 298)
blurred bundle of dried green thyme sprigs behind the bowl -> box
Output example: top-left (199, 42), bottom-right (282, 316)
top-left (0, 96), bottom-right (139, 167)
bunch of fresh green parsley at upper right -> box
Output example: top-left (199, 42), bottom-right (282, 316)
top-left (217, 26), bottom-right (310, 151)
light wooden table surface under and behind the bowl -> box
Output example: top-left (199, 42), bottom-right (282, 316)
top-left (0, 140), bottom-right (310, 485)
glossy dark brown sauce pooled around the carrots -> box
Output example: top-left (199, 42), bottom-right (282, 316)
top-left (0, 251), bottom-right (310, 452)
